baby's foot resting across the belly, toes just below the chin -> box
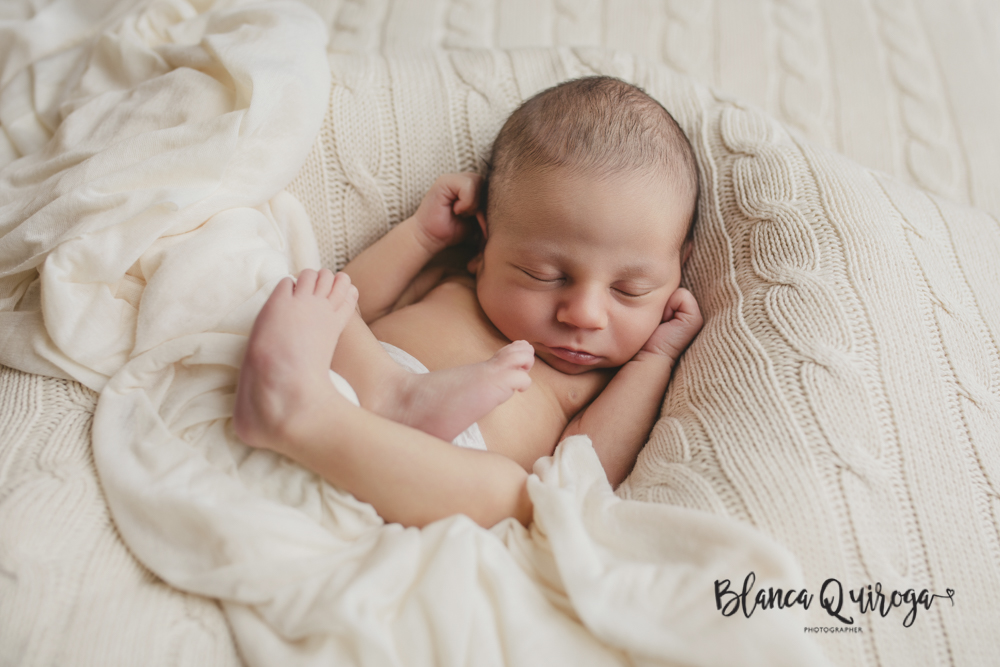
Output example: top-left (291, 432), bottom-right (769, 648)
top-left (379, 340), bottom-right (535, 440)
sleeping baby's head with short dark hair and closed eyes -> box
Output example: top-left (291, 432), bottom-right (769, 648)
top-left (470, 77), bottom-right (698, 373)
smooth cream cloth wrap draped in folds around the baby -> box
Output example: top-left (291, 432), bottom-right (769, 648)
top-left (0, 0), bottom-right (823, 666)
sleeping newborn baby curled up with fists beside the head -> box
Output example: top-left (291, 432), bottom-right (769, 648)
top-left (234, 77), bottom-right (702, 527)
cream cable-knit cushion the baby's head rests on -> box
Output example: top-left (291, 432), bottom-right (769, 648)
top-left (284, 49), bottom-right (1000, 665)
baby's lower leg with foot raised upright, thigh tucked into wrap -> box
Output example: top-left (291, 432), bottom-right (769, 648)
top-left (233, 272), bottom-right (531, 527)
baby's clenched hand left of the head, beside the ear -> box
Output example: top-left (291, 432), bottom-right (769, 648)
top-left (413, 172), bottom-right (483, 254)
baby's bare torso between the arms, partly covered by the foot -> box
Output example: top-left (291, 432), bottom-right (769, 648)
top-left (370, 277), bottom-right (611, 471)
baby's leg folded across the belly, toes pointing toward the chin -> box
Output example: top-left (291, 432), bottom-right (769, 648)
top-left (331, 298), bottom-right (535, 440)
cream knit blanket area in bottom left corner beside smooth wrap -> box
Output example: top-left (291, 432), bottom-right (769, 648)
top-left (0, 367), bottom-right (240, 667)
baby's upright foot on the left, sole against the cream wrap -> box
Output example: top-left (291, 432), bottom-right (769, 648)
top-left (233, 269), bottom-right (358, 449)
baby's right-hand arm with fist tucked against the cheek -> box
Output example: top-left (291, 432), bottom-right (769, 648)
top-left (560, 288), bottom-right (702, 487)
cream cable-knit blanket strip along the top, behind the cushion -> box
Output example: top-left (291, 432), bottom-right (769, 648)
top-left (312, 0), bottom-right (1000, 222)
